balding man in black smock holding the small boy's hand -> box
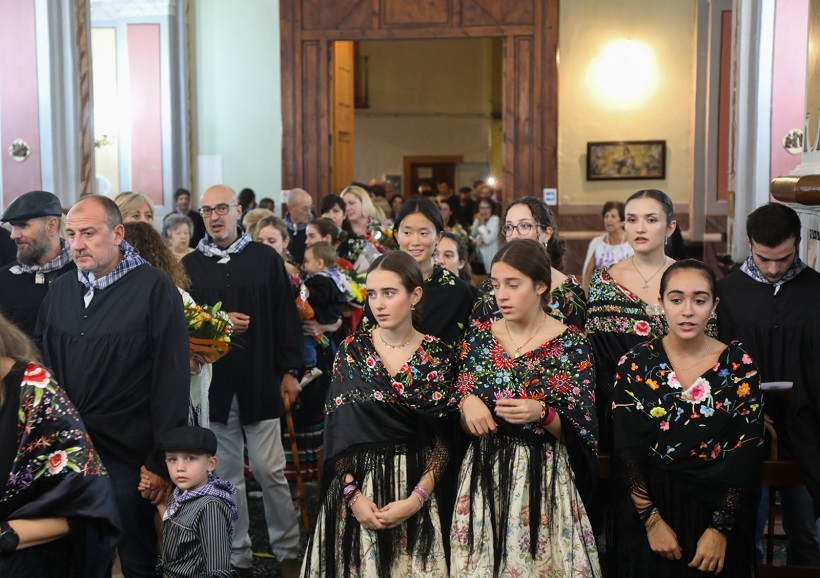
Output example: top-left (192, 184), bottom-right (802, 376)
top-left (35, 195), bottom-right (190, 578)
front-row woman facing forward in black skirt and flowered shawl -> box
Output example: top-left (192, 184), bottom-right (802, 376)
top-left (608, 259), bottom-right (763, 578)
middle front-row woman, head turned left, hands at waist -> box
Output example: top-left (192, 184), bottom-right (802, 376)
top-left (450, 239), bottom-right (601, 578)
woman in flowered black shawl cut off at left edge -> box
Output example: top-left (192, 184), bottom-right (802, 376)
top-left (0, 315), bottom-right (119, 578)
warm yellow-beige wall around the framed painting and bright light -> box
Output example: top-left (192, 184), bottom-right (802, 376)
top-left (558, 0), bottom-right (696, 205)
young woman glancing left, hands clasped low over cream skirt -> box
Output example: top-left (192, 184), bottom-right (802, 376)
top-left (302, 252), bottom-right (454, 577)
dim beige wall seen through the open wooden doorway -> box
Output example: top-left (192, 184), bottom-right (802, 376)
top-left (355, 39), bottom-right (500, 189)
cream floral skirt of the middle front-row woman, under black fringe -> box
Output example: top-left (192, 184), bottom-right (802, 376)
top-left (450, 442), bottom-right (601, 578)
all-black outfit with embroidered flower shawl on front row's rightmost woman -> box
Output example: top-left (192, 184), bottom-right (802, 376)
top-left (607, 338), bottom-right (764, 578)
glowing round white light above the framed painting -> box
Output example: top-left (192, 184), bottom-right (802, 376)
top-left (587, 40), bottom-right (658, 109)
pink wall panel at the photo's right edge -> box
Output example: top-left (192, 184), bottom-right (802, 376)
top-left (771, 0), bottom-right (814, 178)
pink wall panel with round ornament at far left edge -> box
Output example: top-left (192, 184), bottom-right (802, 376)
top-left (0, 0), bottom-right (42, 205)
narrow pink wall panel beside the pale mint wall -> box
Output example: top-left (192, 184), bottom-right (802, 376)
top-left (128, 24), bottom-right (162, 204)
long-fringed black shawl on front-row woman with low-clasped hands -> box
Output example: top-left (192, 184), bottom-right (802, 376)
top-left (308, 332), bottom-right (454, 576)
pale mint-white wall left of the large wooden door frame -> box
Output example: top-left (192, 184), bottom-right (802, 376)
top-left (191, 0), bottom-right (288, 199)
